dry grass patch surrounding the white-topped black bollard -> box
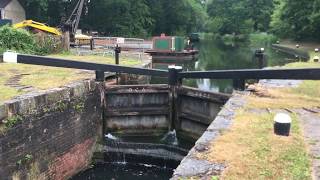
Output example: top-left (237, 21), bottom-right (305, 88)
top-left (200, 110), bottom-right (311, 180)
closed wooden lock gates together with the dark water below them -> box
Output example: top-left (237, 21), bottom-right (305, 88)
top-left (73, 85), bottom-right (230, 179)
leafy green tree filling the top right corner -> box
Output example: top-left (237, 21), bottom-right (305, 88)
top-left (271, 0), bottom-right (320, 41)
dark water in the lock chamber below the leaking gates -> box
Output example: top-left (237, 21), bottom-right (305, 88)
top-left (71, 131), bottom-right (196, 180)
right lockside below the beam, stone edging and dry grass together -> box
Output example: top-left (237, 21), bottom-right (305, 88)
top-left (172, 73), bottom-right (320, 179)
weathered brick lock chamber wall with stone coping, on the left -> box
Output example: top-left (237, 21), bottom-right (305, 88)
top-left (0, 81), bottom-right (102, 180)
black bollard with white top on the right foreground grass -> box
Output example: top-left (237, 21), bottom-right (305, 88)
top-left (274, 113), bottom-right (292, 136)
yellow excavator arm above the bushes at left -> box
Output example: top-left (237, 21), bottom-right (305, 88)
top-left (13, 20), bottom-right (62, 36)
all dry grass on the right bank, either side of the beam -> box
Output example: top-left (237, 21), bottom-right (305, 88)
top-left (198, 63), bottom-right (320, 180)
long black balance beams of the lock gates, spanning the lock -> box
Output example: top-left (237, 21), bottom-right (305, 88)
top-left (17, 55), bottom-right (320, 90)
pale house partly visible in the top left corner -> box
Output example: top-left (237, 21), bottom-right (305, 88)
top-left (0, 0), bottom-right (26, 24)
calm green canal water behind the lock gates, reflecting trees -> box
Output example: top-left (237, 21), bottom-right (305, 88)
top-left (153, 36), bottom-right (297, 93)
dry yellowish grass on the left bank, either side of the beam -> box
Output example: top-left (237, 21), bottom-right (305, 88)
top-left (0, 54), bottom-right (141, 102)
